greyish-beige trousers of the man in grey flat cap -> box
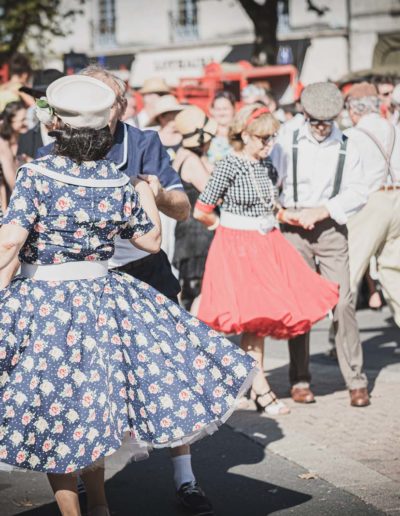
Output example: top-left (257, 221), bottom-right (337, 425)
top-left (282, 219), bottom-right (367, 389)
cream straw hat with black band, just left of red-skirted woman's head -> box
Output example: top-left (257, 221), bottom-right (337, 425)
top-left (175, 106), bottom-right (217, 149)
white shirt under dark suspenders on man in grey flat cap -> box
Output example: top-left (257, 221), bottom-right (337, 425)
top-left (271, 124), bottom-right (367, 224)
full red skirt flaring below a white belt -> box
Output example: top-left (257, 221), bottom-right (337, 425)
top-left (198, 226), bottom-right (339, 339)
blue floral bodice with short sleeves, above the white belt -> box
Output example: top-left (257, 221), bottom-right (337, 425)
top-left (3, 155), bottom-right (153, 264)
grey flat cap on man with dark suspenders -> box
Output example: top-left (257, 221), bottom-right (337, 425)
top-left (301, 82), bottom-right (343, 120)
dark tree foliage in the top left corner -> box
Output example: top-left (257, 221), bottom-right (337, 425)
top-left (0, 0), bottom-right (85, 65)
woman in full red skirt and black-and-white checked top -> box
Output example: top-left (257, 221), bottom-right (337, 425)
top-left (194, 104), bottom-right (338, 415)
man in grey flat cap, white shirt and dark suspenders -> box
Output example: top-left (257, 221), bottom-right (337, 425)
top-left (274, 83), bottom-right (369, 407)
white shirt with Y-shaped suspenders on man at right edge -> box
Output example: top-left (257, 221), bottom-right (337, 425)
top-left (345, 113), bottom-right (400, 194)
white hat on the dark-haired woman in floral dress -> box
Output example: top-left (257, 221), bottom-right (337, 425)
top-left (46, 75), bottom-right (115, 129)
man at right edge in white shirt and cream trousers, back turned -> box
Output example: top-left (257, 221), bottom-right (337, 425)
top-left (346, 82), bottom-right (400, 353)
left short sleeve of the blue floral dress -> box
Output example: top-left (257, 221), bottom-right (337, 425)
top-left (2, 167), bottom-right (40, 232)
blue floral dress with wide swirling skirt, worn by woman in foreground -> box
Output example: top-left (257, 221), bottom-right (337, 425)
top-left (0, 156), bottom-right (254, 473)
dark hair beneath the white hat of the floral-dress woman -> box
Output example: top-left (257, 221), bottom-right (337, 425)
top-left (49, 124), bottom-right (113, 163)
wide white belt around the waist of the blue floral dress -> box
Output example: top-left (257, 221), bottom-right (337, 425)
top-left (21, 260), bottom-right (108, 281)
